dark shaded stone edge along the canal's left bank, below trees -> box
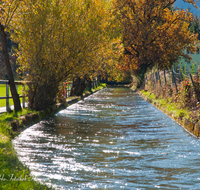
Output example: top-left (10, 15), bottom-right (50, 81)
top-left (10, 88), bottom-right (103, 134)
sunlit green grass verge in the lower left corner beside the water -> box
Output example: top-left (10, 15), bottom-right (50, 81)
top-left (0, 109), bottom-right (54, 190)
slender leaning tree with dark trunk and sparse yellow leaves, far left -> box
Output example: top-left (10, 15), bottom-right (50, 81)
top-left (0, 0), bottom-right (22, 111)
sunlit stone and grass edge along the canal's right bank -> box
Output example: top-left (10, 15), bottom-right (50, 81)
top-left (137, 90), bottom-right (200, 139)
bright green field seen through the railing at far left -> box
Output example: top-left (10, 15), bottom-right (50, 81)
top-left (0, 84), bottom-right (27, 107)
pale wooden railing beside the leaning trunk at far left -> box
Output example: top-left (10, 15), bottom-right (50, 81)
top-left (0, 80), bottom-right (26, 111)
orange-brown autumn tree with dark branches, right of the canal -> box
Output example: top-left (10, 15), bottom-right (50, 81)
top-left (115, 0), bottom-right (197, 85)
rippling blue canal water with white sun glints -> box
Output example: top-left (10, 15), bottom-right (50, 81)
top-left (13, 88), bottom-right (200, 190)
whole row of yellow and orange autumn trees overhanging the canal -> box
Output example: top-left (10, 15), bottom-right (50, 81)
top-left (0, 0), bottom-right (197, 110)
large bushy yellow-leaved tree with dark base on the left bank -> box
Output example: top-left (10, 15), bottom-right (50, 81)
top-left (12, 0), bottom-right (115, 110)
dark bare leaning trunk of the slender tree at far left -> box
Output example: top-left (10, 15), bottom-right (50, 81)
top-left (0, 23), bottom-right (22, 111)
